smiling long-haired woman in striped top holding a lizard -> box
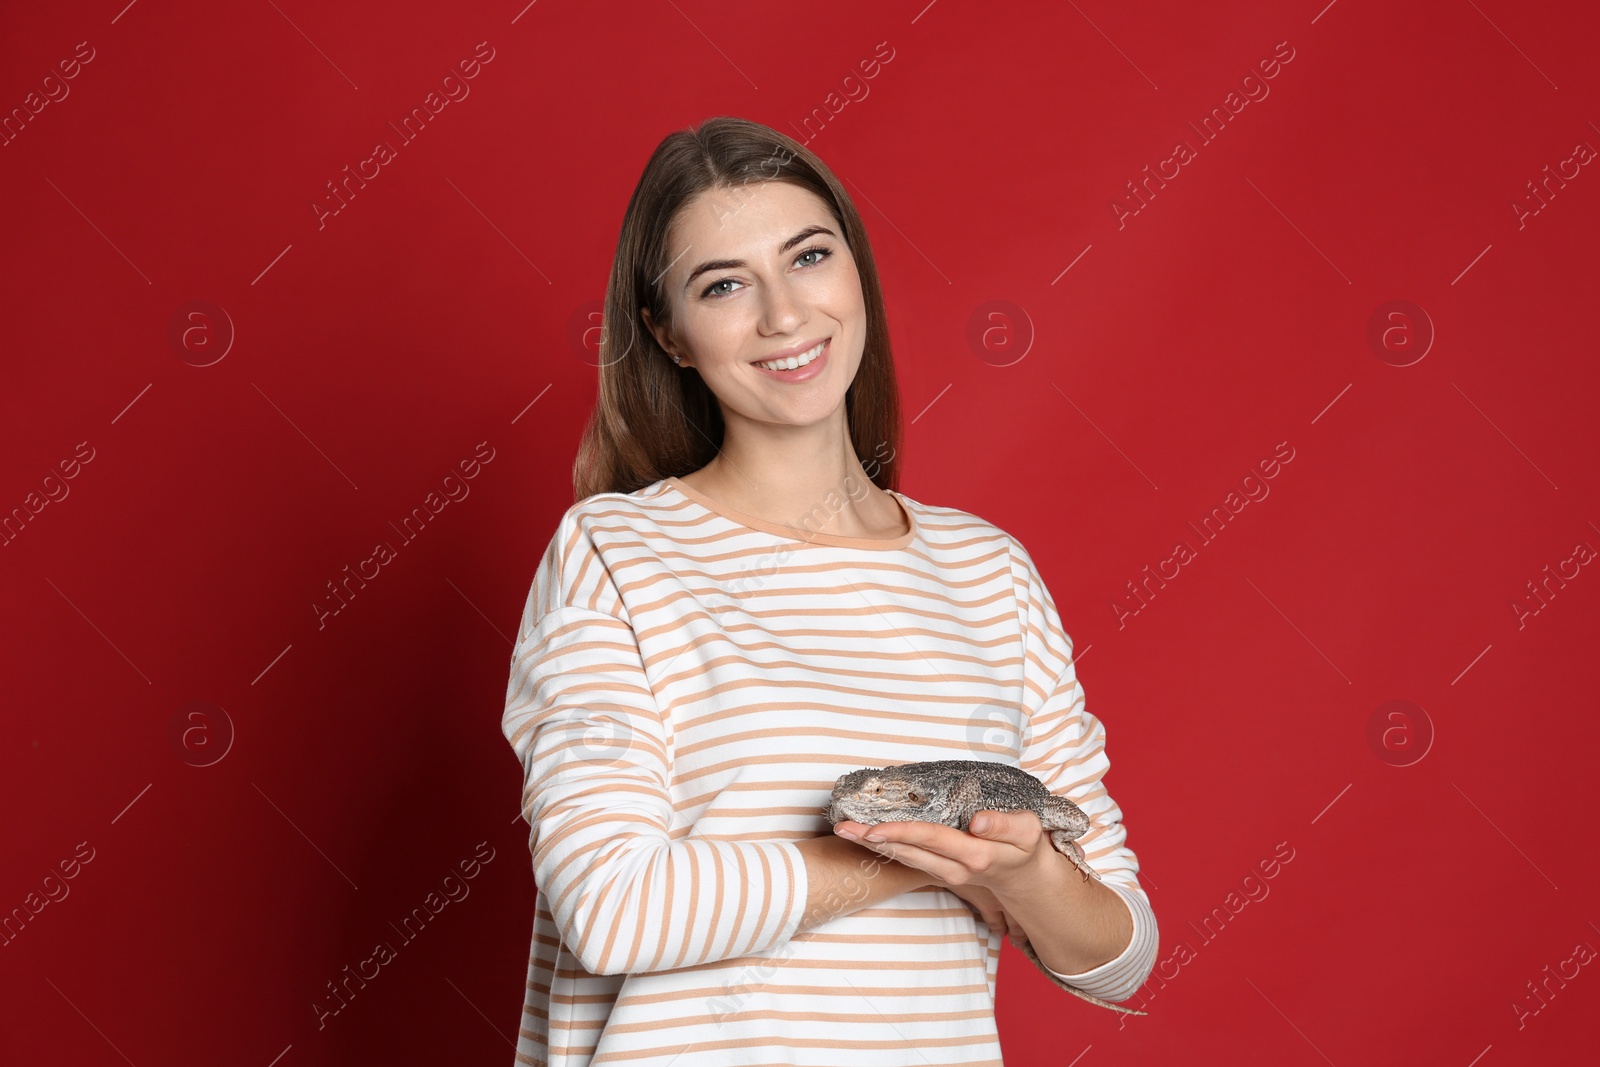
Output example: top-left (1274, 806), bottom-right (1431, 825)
top-left (502, 118), bottom-right (1155, 1067)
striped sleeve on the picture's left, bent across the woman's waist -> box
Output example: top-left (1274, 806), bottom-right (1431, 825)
top-left (502, 510), bottom-right (806, 974)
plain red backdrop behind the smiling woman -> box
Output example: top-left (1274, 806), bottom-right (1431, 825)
top-left (0, 0), bottom-right (1600, 1067)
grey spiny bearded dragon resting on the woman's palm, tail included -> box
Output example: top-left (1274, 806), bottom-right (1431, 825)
top-left (822, 760), bottom-right (1146, 1016)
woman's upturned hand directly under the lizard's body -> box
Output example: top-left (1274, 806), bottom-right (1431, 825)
top-left (834, 809), bottom-right (1058, 899)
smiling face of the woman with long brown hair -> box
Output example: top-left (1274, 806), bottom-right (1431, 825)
top-left (643, 181), bottom-right (867, 432)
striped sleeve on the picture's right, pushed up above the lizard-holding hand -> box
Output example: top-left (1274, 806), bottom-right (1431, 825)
top-left (1011, 539), bottom-right (1158, 1001)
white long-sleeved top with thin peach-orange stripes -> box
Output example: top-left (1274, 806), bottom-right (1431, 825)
top-left (502, 478), bottom-right (1157, 1067)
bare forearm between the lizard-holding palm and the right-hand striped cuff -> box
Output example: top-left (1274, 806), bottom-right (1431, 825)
top-left (995, 848), bottom-right (1133, 974)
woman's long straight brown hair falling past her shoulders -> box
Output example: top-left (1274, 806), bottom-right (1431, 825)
top-left (573, 117), bottom-right (901, 501)
